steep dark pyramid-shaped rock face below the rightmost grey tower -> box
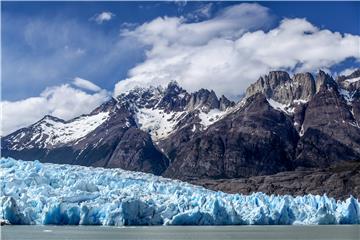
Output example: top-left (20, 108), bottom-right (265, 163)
top-left (296, 72), bottom-right (360, 167)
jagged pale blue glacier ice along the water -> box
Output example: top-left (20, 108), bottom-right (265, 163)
top-left (0, 158), bottom-right (360, 225)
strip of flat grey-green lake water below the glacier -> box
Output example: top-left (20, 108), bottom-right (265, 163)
top-left (1, 225), bottom-right (360, 240)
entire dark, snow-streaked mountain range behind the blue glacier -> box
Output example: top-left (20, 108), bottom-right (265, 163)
top-left (1, 70), bottom-right (360, 198)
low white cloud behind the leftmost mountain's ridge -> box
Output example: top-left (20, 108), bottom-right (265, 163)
top-left (0, 84), bottom-right (109, 136)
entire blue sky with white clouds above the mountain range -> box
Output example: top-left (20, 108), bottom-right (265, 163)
top-left (1, 1), bottom-right (360, 135)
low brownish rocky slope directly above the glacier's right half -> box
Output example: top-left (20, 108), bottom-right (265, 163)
top-left (190, 161), bottom-right (360, 200)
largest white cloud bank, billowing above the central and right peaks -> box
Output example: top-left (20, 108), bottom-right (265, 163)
top-left (114, 3), bottom-right (360, 97)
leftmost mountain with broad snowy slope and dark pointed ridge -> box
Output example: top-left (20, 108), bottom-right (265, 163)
top-left (2, 99), bottom-right (168, 174)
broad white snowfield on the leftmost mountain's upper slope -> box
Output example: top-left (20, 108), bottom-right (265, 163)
top-left (13, 112), bottom-right (109, 150)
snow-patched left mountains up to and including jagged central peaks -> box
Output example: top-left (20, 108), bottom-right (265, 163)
top-left (2, 82), bottom-right (234, 175)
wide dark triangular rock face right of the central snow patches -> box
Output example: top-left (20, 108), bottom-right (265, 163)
top-left (165, 94), bottom-right (297, 179)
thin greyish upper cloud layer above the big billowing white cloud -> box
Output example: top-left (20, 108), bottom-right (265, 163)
top-left (122, 3), bottom-right (274, 48)
